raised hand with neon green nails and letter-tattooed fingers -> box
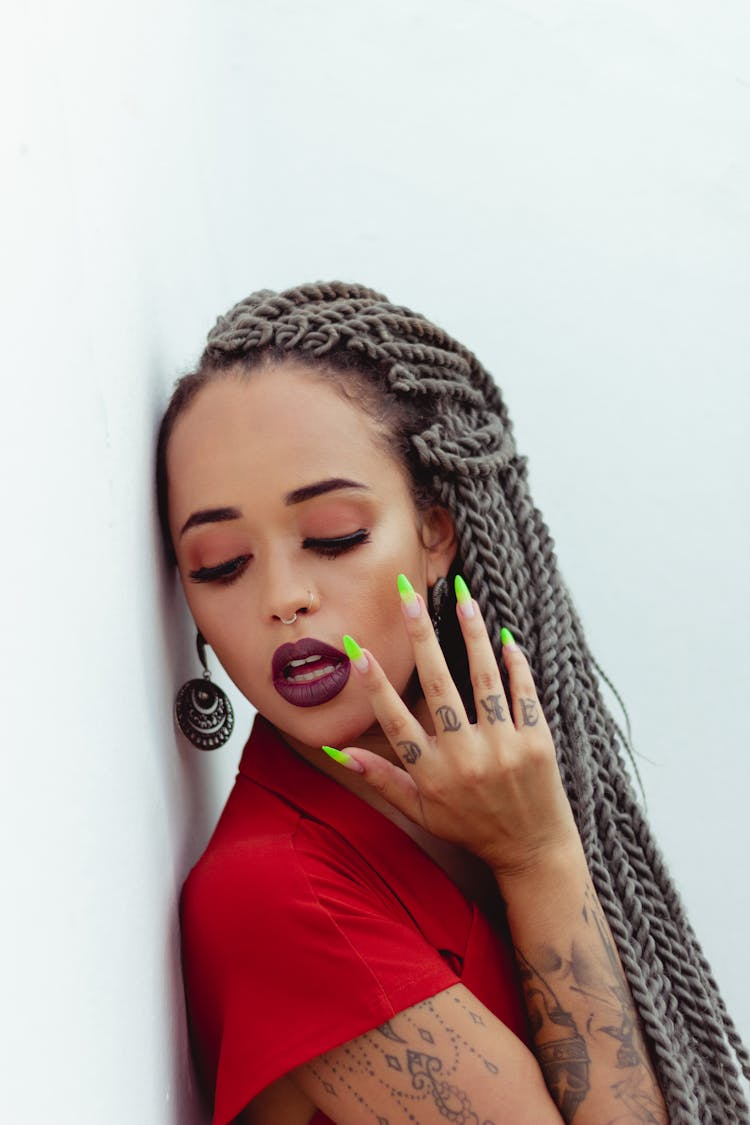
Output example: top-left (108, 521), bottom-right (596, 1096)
top-left (332, 579), bottom-right (580, 879)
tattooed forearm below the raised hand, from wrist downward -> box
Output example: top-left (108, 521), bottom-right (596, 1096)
top-left (496, 842), bottom-right (668, 1125)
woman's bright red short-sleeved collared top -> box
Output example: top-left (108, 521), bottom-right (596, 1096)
top-left (181, 716), bottom-right (526, 1125)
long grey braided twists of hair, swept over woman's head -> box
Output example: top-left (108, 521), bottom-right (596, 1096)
top-left (157, 282), bottom-right (750, 1125)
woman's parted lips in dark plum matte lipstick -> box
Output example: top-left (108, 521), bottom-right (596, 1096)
top-left (271, 637), bottom-right (352, 707)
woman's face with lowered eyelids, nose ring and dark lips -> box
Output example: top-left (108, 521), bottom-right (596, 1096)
top-left (166, 362), bottom-right (455, 747)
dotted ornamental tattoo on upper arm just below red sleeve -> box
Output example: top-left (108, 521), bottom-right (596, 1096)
top-left (308, 998), bottom-right (500, 1125)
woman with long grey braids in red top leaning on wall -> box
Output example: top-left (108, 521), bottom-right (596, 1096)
top-left (157, 284), bottom-right (750, 1125)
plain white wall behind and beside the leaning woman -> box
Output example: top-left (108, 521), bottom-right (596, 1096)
top-left (0, 0), bottom-right (750, 1125)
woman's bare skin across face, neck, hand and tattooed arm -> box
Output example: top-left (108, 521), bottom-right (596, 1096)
top-left (168, 362), bottom-right (667, 1125)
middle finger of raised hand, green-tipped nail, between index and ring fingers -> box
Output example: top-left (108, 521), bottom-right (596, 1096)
top-left (398, 574), bottom-right (469, 739)
